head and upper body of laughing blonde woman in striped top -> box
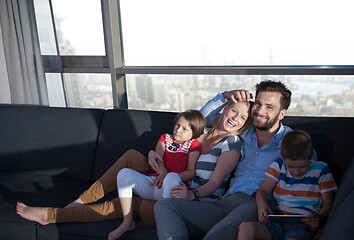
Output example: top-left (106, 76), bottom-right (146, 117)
top-left (171, 101), bottom-right (251, 201)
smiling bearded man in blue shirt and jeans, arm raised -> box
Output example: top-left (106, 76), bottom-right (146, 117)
top-left (155, 81), bottom-right (291, 240)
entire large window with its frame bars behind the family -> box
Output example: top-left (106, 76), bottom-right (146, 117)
top-left (33, 0), bottom-right (354, 116)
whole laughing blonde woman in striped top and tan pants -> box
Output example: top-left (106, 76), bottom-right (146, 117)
top-left (14, 102), bottom-right (251, 238)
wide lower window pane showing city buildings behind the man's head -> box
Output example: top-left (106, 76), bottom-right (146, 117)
top-left (127, 75), bottom-right (354, 117)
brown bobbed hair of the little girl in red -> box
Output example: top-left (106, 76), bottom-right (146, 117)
top-left (175, 109), bottom-right (206, 139)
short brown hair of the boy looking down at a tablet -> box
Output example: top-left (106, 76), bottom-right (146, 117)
top-left (280, 130), bottom-right (313, 161)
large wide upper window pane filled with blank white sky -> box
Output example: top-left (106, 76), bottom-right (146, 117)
top-left (120, 0), bottom-right (354, 66)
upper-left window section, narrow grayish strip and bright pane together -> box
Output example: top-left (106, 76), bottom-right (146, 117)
top-left (34, 0), bottom-right (106, 55)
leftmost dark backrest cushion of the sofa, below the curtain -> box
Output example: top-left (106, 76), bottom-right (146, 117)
top-left (0, 105), bottom-right (103, 181)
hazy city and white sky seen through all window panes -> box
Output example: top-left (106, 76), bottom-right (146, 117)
top-left (35, 0), bottom-right (354, 116)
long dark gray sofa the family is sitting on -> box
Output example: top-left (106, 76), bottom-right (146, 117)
top-left (0, 105), bottom-right (354, 240)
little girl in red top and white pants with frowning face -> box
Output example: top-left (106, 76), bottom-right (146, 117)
top-left (108, 110), bottom-right (205, 240)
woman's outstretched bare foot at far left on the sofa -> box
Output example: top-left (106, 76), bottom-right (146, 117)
top-left (16, 202), bottom-right (48, 225)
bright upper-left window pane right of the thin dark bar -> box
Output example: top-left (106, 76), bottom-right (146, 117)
top-left (52, 0), bottom-right (106, 55)
